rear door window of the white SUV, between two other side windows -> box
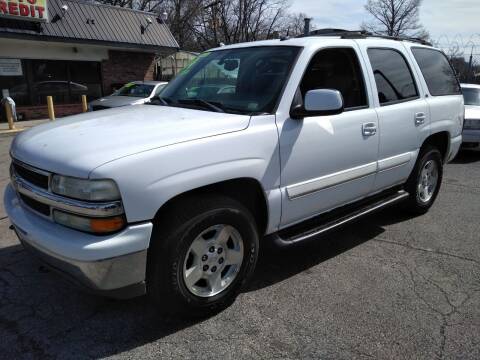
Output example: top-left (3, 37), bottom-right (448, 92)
top-left (368, 49), bottom-right (418, 105)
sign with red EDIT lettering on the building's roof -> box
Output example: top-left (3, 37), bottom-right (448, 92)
top-left (0, 0), bottom-right (48, 21)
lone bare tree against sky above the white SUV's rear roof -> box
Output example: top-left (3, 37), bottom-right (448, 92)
top-left (362, 0), bottom-right (429, 39)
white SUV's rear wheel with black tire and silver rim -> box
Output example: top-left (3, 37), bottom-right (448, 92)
top-left (405, 146), bottom-right (443, 215)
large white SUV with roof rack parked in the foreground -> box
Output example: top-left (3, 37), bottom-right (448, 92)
top-left (4, 32), bottom-right (464, 314)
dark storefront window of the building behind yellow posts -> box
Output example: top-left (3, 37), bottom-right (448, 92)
top-left (0, 60), bottom-right (102, 106)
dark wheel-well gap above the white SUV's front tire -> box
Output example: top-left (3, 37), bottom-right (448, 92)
top-left (155, 178), bottom-right (268, 235)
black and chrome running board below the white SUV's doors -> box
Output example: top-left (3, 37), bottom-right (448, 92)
top-left (272, 190), bottom-right (409, 247)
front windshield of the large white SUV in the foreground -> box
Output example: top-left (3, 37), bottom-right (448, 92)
top-left (161, 46), bottom-right (300, 114)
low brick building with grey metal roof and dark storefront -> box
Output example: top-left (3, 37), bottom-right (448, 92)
top-left (0, 0), bottom-right (178, 119)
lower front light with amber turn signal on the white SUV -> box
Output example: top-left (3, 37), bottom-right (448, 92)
top-left (53, 210), bottom-right (125, 234)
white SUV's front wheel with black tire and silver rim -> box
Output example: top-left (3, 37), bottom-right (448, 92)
top-left (147, 195), bottom-right (259, 316)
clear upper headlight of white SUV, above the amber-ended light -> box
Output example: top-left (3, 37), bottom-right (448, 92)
top-left (50, 175), bottom-right (120, 201)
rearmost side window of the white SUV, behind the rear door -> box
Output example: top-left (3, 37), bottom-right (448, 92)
top-left (412, 48), bottom-right (461, 96)
